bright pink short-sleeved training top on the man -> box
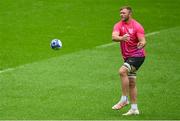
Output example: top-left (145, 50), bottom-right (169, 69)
top-left (113, 19), bottom-right (145, 59)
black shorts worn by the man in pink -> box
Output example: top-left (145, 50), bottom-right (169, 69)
top-left (124, 57), bottom-right (145, 70)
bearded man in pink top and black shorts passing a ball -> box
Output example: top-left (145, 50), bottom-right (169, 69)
top-left (112, 6), bottom-right (146, 115)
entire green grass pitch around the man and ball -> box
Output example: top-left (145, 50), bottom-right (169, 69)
top-left (0, 0), bottom-right (180, 120)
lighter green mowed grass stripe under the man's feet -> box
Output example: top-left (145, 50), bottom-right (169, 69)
top-left (0, 27), bottom-right (180, 120)
